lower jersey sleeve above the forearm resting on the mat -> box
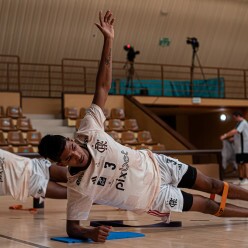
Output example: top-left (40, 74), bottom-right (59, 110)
top-left (67, 188), bottom-right (93, 220)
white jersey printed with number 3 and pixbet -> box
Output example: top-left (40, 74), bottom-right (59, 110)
top-left (67, 104), bottom-right (161, 220)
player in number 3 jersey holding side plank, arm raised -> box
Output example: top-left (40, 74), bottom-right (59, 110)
top-left (39, 11), bottom-right (248, 242)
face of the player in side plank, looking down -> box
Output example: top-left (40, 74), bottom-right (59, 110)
top-left (60, 140), bottom-right (89, 167)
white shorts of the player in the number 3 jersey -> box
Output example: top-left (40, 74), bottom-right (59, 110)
top-left (148, 154), bottom-right (188, 221)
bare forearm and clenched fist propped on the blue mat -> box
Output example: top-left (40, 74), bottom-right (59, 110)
top-left (66, 220), bottom-right (111, 242)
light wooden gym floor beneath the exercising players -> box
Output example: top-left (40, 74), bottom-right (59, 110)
top-left (0, 177), bottom-right (248, 248)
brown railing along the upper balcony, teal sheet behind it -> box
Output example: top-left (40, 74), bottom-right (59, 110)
top-left (0, 55), bottom-right (247, 99)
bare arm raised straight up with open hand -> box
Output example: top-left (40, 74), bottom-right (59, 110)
top-left (93, 10), bottom-right (114, 109)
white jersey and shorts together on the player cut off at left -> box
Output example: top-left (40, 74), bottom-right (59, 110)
top-left (0, 149), bottom-right (51, 201)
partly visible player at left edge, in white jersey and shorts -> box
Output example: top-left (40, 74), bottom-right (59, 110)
top-left (0, 149), bottom-right (67, 201)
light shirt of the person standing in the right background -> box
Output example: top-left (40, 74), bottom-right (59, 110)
top-left (234, 119), bottom-right (248, 154)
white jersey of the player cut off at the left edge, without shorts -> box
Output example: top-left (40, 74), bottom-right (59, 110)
top-left (0, 149), bottom-right (32, 201)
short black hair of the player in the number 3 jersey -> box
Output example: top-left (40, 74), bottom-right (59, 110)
top-left (38, 134), bottom-right (66, 162)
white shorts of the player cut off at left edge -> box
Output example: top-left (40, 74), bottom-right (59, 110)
top-left (29, 159), bottom-right (51, 198)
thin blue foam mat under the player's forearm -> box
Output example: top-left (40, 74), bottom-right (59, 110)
top-left (51, 232), bottom-right (145, 243)
